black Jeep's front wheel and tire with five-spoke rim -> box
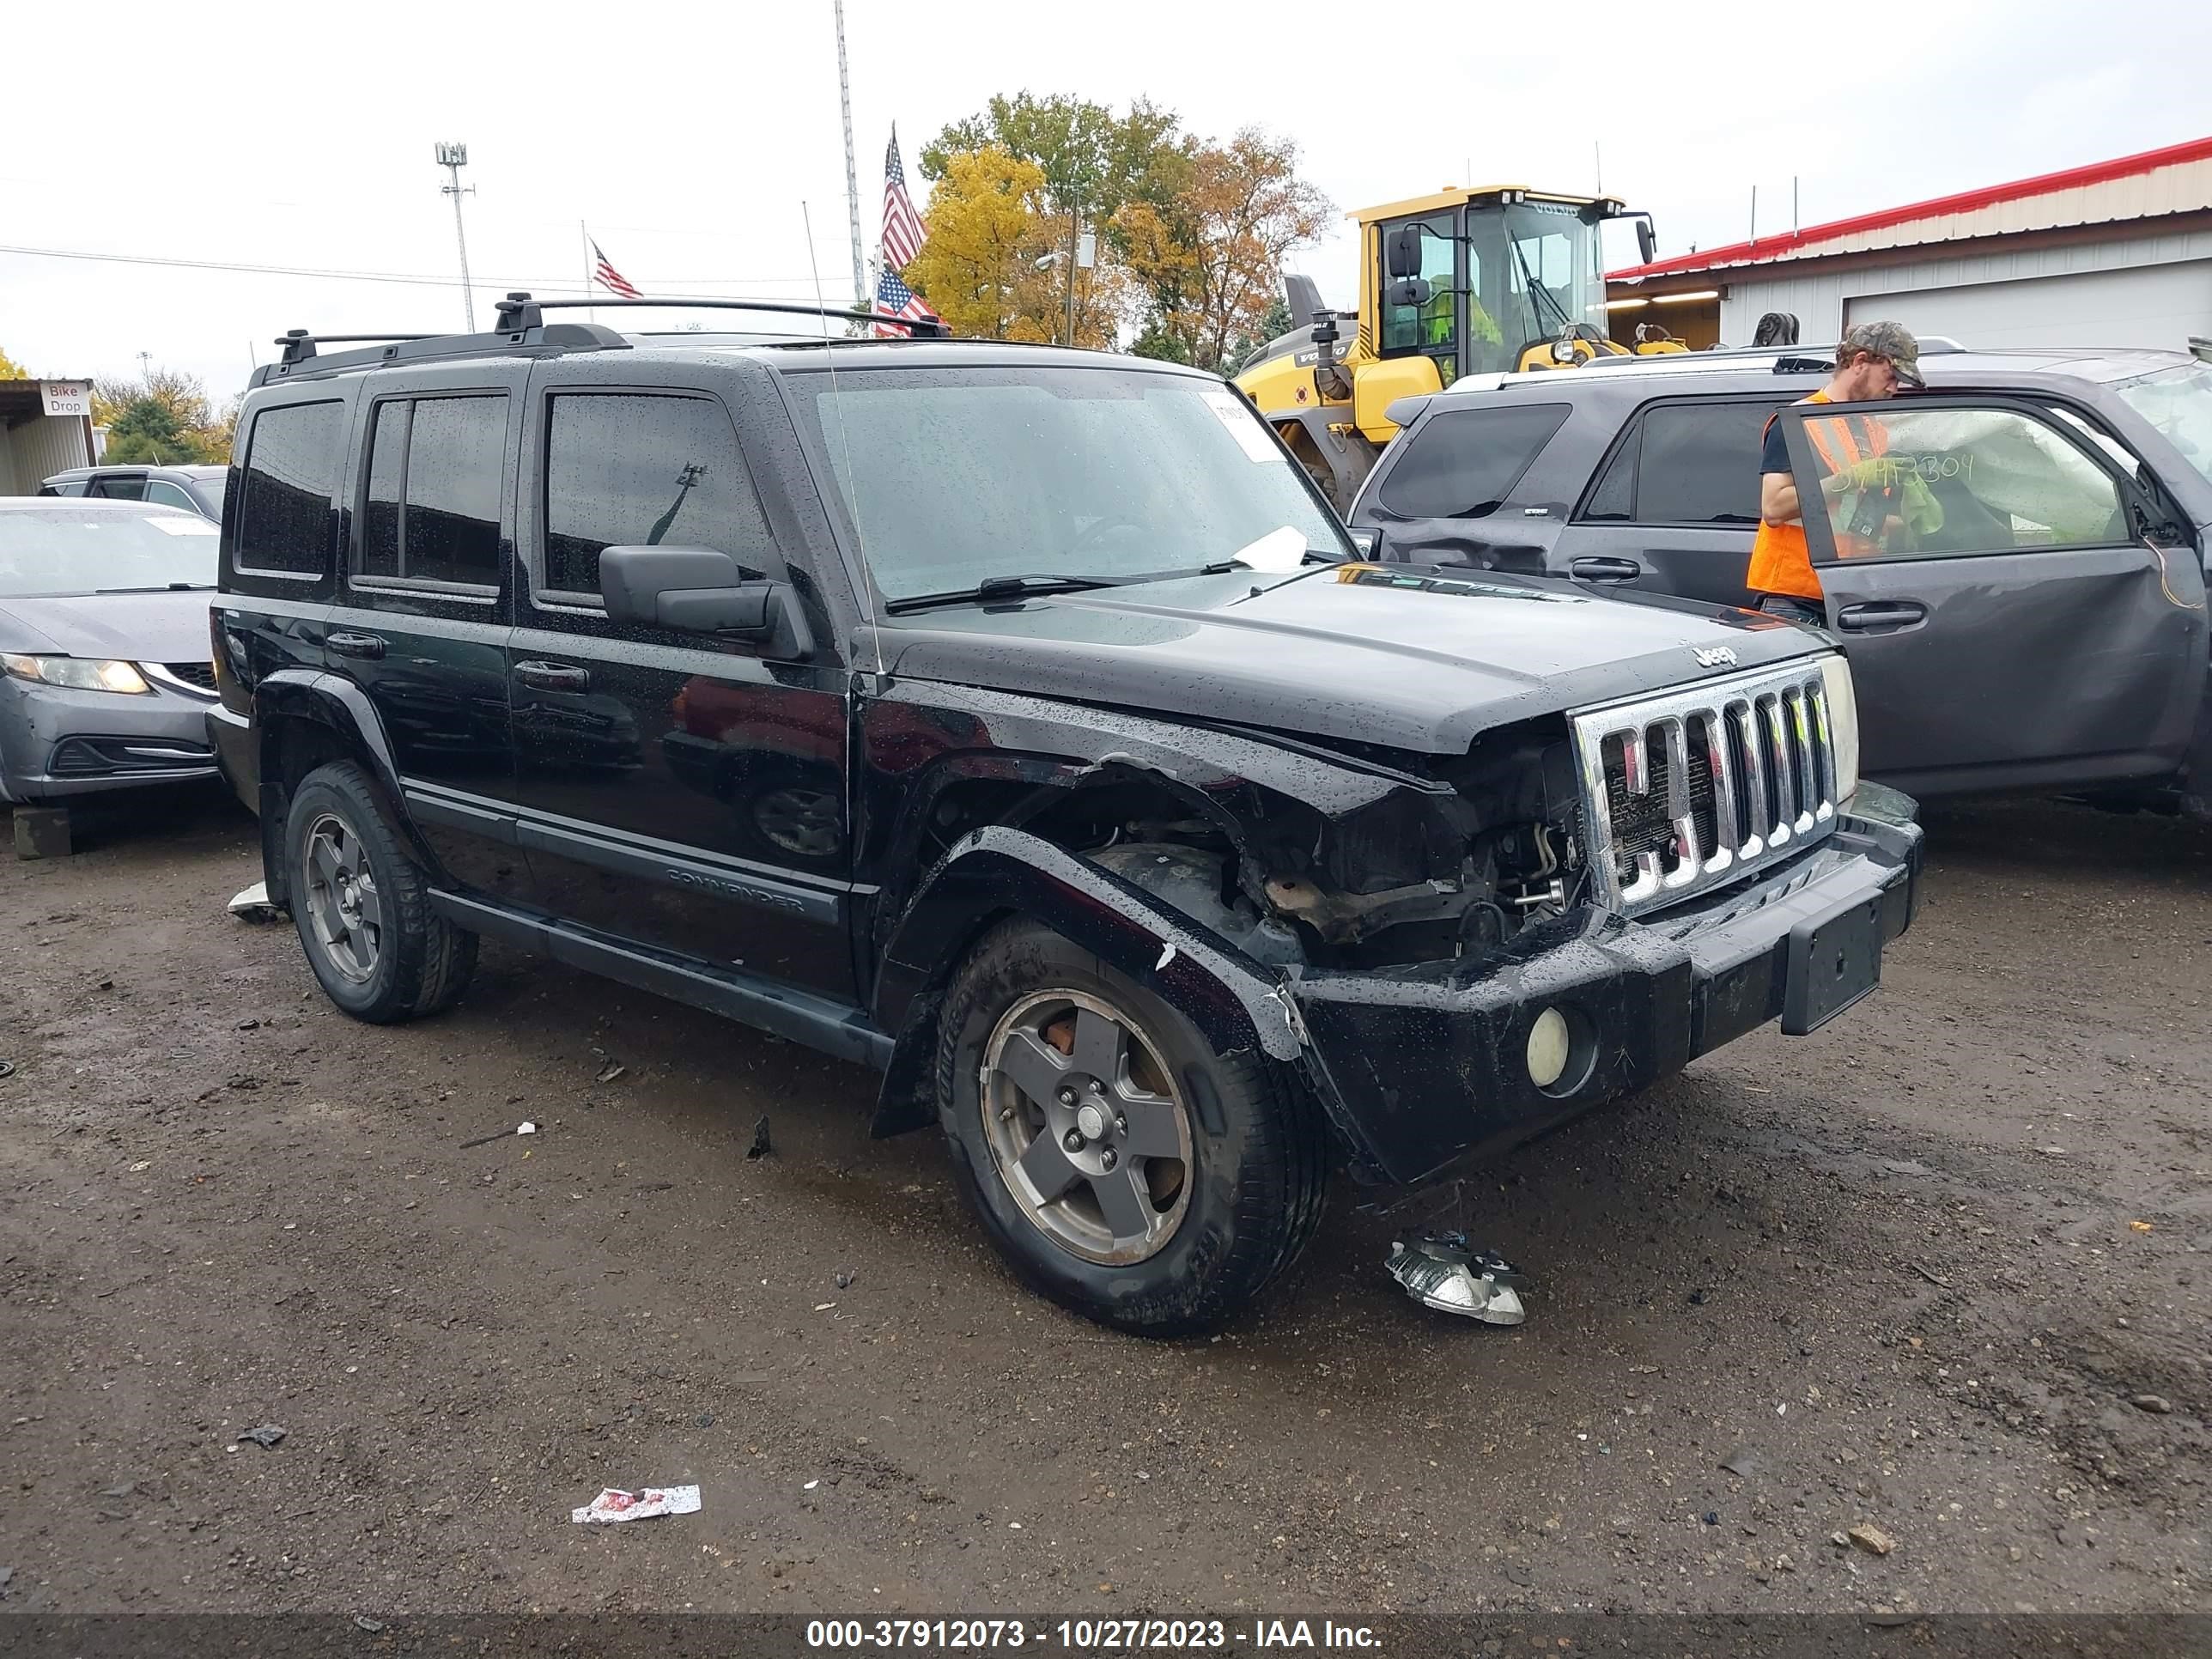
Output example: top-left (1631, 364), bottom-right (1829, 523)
top-left (936, 921), bottom-right (1329, 1336)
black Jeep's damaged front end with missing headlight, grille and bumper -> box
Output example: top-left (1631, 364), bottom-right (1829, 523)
top-left (878, 672), bottom-right (1920, 1186)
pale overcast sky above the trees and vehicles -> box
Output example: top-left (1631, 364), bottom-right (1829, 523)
top-left (0, 0), bottom-right (2212, 396)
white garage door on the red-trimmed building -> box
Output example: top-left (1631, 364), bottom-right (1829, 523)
top-left (1843, 258), bottom-right (2212, 352)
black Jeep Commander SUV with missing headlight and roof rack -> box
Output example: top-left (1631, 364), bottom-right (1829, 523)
top-left (210, 296), bottom-right (1917, 1332)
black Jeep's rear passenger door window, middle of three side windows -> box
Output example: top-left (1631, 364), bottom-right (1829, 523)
top-left (358, 394), bottom-right (507, 588)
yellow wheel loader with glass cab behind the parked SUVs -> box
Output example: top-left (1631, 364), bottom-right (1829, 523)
top-left (1234, 185), bottom-right (1686, 511)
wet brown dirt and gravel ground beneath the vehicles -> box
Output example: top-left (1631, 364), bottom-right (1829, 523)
top-left (0, 801), bottom-right (2212, 1614)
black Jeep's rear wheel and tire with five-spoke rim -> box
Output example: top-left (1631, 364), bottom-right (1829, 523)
top-left (283, 761), bottom-right (476, 1024)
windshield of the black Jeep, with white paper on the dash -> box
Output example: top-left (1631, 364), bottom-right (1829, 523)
top-left (792, 365), bottom-right (1352, 599)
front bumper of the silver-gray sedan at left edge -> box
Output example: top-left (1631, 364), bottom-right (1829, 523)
top-left (0, 679), bottom-right (215, 801)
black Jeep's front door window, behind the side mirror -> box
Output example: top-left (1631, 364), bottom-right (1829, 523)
top-left (544, 392), bottom-right (783, 599)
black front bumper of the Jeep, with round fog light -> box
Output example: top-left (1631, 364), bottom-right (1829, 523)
top-left (1287, 800), bottom-right (1920, 1183)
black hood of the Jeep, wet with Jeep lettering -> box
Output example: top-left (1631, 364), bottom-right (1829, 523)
top-left (876, 566), bottom-right (1823, 754)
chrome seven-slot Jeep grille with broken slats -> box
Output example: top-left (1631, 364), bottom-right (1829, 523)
top-left (1568, 657), bottom-right (1836, 915)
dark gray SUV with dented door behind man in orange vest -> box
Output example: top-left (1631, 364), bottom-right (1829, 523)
top-left (1352, 347), bottom-right (2212, 811)
